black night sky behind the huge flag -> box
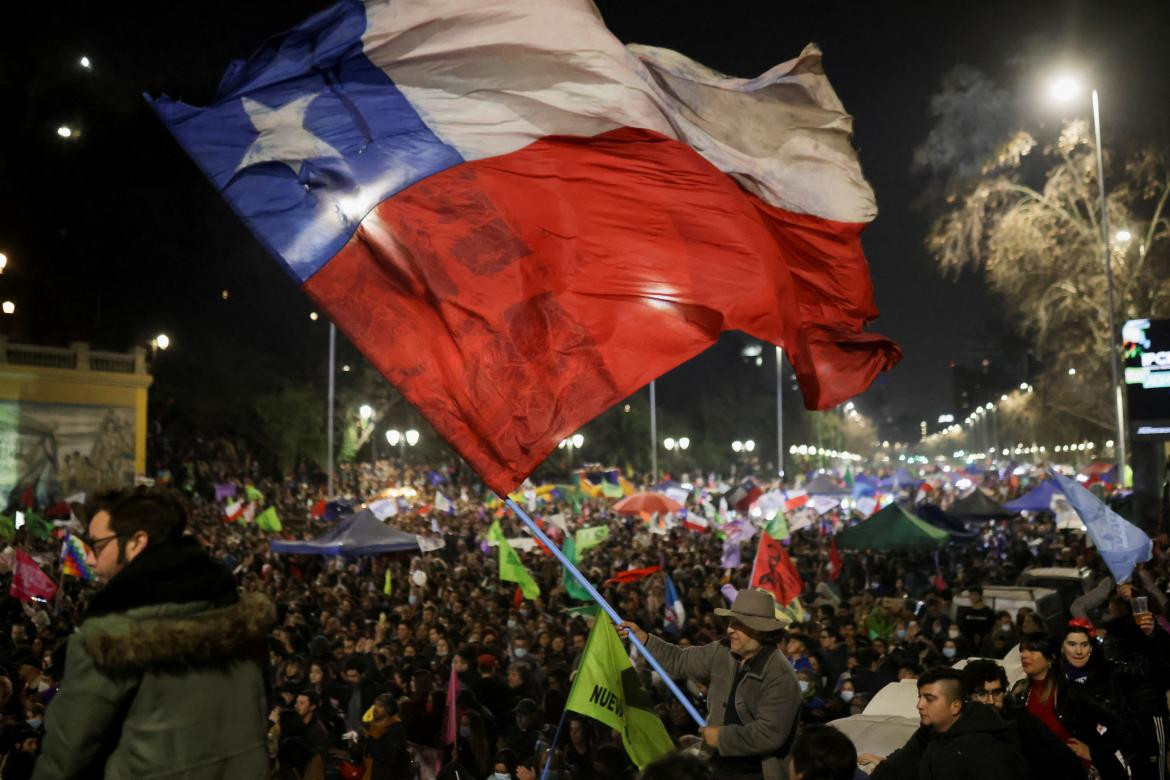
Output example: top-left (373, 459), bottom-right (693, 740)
top-left (0, 0), bottom-right (1170, 439)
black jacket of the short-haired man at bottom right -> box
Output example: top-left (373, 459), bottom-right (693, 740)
top-left (872, 702), bottom-right (1029, 780)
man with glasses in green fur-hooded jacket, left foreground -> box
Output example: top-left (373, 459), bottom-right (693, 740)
top-left (34, 489), bottom-right (275, 780)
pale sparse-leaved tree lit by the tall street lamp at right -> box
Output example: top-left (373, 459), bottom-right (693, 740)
top-left (927, 120), bottom-right (1170, 429)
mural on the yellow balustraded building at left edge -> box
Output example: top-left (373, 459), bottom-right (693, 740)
top-left (0, 401), bottom-right (135, 504)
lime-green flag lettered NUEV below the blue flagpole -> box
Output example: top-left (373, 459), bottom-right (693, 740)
top-left (565, 619), bottom-right (674, 769)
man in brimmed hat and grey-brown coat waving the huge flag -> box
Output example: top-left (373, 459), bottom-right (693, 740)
top-left (621, 588), bottom-right (800, 780)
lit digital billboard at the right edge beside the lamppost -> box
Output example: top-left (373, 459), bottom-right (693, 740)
top-left (1121, 319), bottom-right (1170, 439)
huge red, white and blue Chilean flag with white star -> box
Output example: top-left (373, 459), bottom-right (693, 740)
top-left (151, 0), bottom-right (900, 492)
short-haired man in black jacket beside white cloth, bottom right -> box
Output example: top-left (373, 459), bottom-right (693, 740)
top-left (858, 667), bottom-right (1032, 780)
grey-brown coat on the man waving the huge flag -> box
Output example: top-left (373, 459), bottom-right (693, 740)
top-left (646, 635), bottom-right (800, 780)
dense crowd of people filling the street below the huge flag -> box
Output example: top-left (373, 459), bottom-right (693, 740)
top-left (0, 446), bottom-right (1170, 780)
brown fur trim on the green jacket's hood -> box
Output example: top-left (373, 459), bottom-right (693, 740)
top-left (82, 593), bottom-right (276, 674)
